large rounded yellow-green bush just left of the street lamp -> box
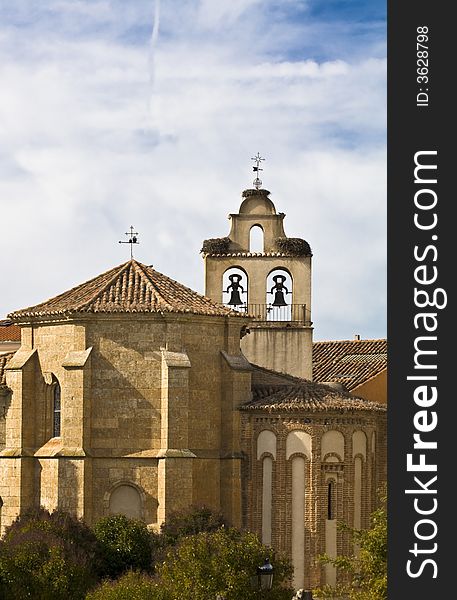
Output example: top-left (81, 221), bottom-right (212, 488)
top-left (157, 527), bottom-right (293, 600)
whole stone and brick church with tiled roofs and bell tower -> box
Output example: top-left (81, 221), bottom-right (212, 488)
top-left (0, 185), bottom-right (386, 589)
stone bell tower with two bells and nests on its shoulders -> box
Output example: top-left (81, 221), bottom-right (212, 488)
top-left (202, 164), bottom-right (313, 379)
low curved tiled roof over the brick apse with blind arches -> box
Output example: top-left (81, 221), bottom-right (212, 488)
top-left (241, 379), bottom-right (386, 412)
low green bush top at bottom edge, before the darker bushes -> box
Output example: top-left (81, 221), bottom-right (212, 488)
top-left (86, 571), bottom-right (171, 600)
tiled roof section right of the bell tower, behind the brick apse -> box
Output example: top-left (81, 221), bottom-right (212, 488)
top-left (313, 339), bottom-right (387, 391)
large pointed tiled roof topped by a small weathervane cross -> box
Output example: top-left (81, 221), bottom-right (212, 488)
top-left (8, 259), bottom-right (245, 320)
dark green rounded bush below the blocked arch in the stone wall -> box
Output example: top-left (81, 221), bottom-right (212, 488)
top-left (94, 515), bottom-right (152, 578)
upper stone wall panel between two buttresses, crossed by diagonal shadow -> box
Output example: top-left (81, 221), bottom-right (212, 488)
top-left (86, 315), bottom-right (166, 457)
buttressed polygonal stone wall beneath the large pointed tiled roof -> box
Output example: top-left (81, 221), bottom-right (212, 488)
top-left (0, 314), bottom-right (250, 527)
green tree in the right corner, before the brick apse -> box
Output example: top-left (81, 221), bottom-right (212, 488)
top-left (314, 488), bottom-right (387, 600)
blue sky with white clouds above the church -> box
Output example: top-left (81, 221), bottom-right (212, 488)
top-left (0, 0), bottom-right (386, 339)
